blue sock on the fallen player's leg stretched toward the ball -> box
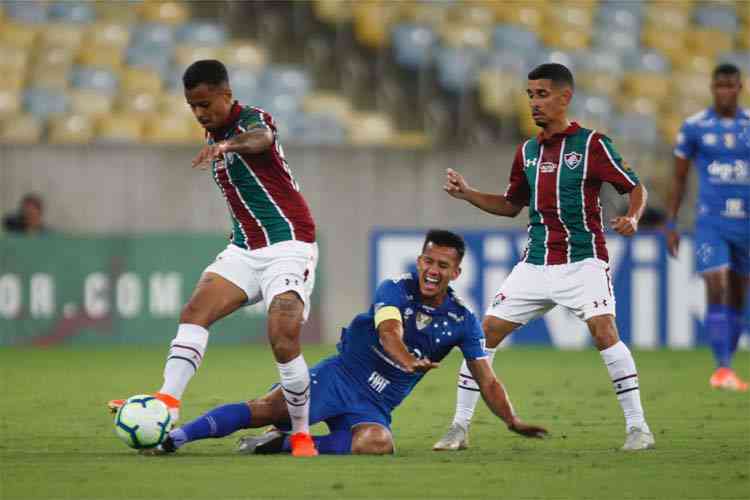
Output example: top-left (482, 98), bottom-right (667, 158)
top-left (169, 403), bottom-right (252, 448)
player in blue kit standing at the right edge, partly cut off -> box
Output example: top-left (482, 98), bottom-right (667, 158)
top-left (665, 64), bottom-right (750, 391)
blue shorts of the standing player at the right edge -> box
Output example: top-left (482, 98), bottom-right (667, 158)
top-left (695, 218), bottom-right (750, 276)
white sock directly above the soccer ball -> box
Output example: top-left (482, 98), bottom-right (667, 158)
top-left (159, 323), bottom-right (208, 399)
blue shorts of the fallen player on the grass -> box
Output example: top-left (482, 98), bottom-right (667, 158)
top-left (278, 356), bottom-right (391, 432)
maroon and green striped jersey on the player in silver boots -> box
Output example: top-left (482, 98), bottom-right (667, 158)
top-left (505, 122), bottom-right (639, 265)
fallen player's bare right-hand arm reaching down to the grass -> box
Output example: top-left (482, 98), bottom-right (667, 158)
top-left (466, 358), bottom-right (547, 438)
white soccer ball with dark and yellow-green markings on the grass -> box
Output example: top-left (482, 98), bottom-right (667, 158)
top-left (115, 394), bottom-right (172, 449)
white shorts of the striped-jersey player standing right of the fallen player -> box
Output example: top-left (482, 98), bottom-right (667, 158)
top-left (486, 258), bottom-right (615, 325)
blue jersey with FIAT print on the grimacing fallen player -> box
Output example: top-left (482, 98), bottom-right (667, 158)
top-left (337, 274), bottom-right (486, 412)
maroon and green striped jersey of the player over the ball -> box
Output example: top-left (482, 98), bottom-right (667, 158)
top-left (206, 102), bottom-right (315, 250)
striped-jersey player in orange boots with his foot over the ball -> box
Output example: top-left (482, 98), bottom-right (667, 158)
top-left (109, 60), bottom-right (318, 456)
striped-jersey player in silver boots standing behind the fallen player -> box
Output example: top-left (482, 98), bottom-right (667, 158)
top-left (433, 64), bottom-right (654, 450)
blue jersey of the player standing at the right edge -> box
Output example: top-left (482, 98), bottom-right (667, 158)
top-left (674, 108), bottom-right (750, 224)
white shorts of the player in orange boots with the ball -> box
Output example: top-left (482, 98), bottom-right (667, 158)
top-left (204, 240), bottom-right (318, 320)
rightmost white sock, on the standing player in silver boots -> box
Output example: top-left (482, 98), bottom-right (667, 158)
top-left (600, 341), bottom-right (651, 432)
